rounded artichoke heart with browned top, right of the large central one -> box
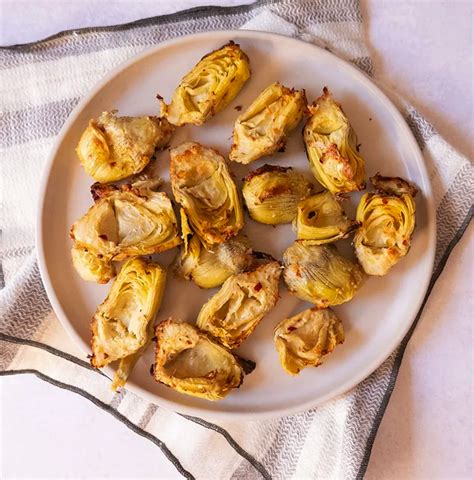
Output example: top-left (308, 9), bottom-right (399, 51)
top-left (242, 165), bottom-right (313, 225)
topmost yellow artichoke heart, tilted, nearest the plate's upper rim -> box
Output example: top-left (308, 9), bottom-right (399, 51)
top-left (158, 42), bottom-right (250, 126)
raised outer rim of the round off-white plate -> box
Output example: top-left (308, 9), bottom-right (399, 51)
top-left (35, 29), bottom-right (436, 420)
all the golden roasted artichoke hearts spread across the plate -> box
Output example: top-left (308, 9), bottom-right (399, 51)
top-left (70, 42), bottom-right (417, 400)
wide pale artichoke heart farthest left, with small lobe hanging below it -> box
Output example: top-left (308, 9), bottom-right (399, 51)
top-left (71, 181), bottom-right (181, 283)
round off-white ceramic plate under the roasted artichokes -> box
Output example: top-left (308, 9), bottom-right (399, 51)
top-left (37, 31), bottom-right (435, 418)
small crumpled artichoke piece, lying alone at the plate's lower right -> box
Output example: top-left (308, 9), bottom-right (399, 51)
top-left (273, 307), bottom-right (344, 375)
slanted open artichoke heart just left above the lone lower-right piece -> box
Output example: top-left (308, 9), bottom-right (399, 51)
top-left (196, 261), bottom-right (281, 348)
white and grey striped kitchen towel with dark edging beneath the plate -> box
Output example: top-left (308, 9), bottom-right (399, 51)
top-left (0, 0), bottom-right (474, 479)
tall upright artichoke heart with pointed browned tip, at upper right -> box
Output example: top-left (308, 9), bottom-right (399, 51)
top-left (303, 87), bottom-right (365, 193)
